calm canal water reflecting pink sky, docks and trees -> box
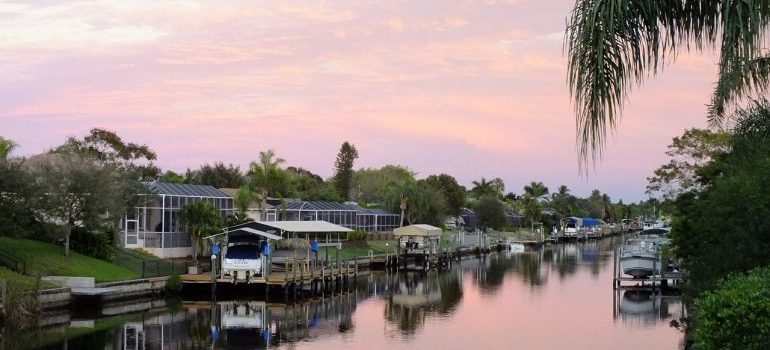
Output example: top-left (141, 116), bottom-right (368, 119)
top-left (15, 237), bottom-right (684, 350)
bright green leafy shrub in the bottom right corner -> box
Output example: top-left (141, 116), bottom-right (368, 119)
top-left (693, 266), bottom-right (770, 350)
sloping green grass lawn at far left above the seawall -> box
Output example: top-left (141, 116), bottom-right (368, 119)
top-left (0, 237), bottom-right (140, 282)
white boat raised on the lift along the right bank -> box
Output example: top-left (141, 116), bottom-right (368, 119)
top-left (620, 234), bottom-right (668, 278)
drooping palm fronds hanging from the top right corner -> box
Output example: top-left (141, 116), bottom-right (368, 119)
top-left (565, 0), bottom-right (770, 161)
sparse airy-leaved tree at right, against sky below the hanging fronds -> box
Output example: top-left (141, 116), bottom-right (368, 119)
top-left (645, 128), bottom-right (730, 200)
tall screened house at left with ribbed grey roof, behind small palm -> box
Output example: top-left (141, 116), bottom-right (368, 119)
top-left (121, 182), bottom-right (233, 258)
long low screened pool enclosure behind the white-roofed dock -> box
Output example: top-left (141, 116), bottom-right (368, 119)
top-left (282, 201), bottom-right (399, 232)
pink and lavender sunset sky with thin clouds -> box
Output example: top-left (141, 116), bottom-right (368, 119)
top-left (0, 0), bottom-right (715, 201)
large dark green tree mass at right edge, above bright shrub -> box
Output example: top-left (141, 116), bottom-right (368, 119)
top-left (671, 100), bottom-right (770, 294)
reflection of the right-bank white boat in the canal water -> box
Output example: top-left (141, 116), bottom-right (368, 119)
top-left (614, 290), bottom-right (685, 327)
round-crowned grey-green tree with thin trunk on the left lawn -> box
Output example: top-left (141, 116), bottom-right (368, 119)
top-left (27, 152), bottom-right (128, 256)
